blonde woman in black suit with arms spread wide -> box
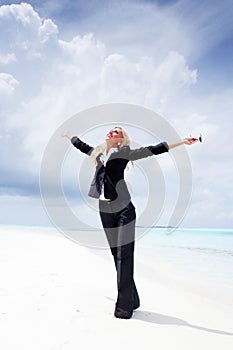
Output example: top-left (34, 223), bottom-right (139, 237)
top-left (62, 126), bottom-right (198, 319)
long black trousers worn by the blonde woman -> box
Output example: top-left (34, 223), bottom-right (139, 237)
top-left (99, 200), bottom-right (140, 311)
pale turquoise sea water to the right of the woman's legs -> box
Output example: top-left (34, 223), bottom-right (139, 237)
top-left (136, 228), bottom-right (233, 304)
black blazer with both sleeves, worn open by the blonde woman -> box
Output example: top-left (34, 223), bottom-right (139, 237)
top-left (71, 136), bottom-right (169, 201)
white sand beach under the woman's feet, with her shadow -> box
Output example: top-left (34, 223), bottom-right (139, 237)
top-left (0, 227), bottom-right (233, 350)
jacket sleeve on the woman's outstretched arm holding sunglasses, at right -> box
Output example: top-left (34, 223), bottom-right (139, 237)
top-left (124, 142), bottom-right (169, 160)
